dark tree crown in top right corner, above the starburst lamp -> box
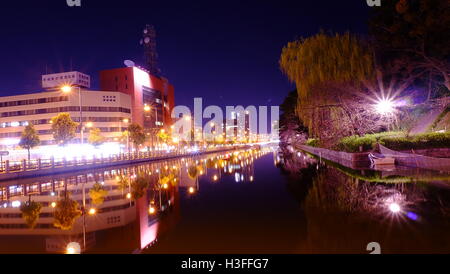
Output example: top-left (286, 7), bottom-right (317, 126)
top-left (369, 0), bottom-right (450, 99)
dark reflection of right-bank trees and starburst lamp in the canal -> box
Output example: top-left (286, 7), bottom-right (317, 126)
top-left (277, 146), bottom-right (450, 253)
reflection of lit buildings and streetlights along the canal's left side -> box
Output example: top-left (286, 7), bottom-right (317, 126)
top-left (0, 149), bottom-right (267, 253)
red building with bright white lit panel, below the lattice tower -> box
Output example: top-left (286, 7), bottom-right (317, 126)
top-left (100, 66), bottom-right (175, 130)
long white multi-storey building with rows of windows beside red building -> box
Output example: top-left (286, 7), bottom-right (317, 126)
top-left (0, 89), bottom-right (131, 150)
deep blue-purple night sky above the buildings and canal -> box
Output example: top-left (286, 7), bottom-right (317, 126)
top-left (0, 0), bottom-right (370, 109)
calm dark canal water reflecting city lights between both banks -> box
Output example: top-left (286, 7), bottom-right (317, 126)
top-left (0, 147), bottom-right (450, 254)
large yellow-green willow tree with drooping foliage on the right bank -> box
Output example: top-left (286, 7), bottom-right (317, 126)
top-left (280, 32), bottom-right (374, 142)
